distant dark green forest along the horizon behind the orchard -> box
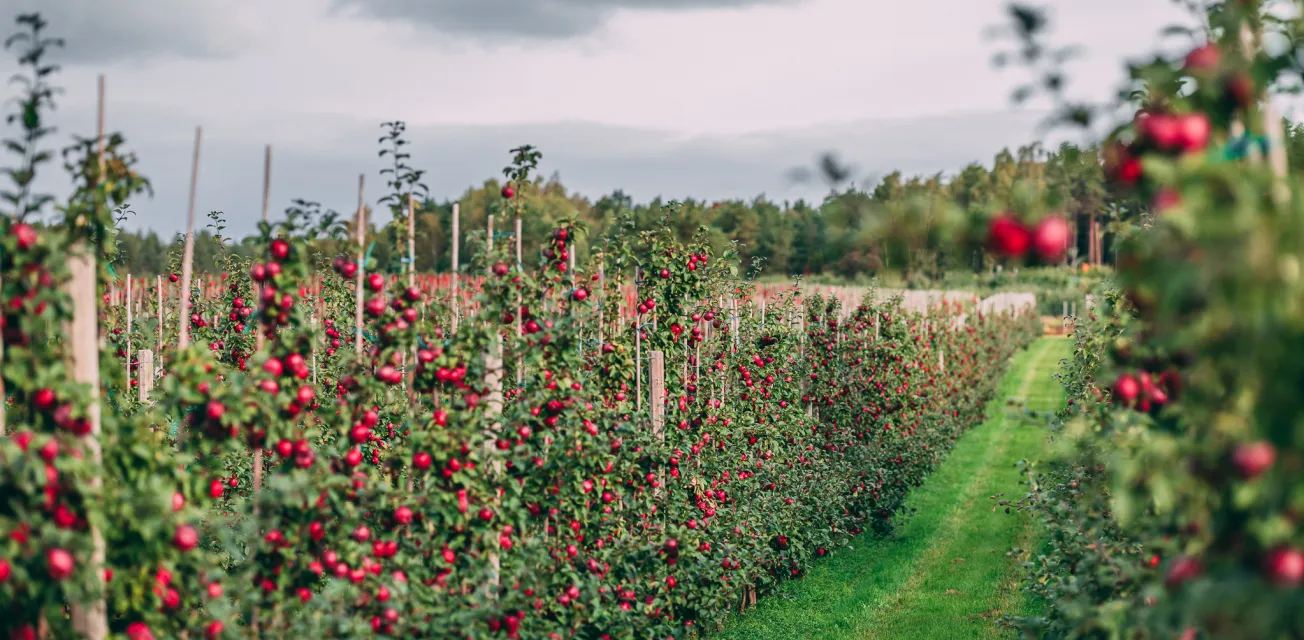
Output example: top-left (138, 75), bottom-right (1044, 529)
top-left (115, 123), bottom-right (1304, 282)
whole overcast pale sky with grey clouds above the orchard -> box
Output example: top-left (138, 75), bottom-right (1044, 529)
top-left (0, 0), bottom-right (1189, 233)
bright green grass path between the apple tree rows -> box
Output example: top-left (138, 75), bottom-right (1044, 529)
top-left (719, 338), bottom-right (1071, 639)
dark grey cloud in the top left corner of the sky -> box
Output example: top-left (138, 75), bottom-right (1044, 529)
top-left (0, 0), bottom-right (258, 66)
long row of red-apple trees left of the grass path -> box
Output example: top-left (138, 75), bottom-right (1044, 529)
top-left (0, 16), bottom-right (1037, 639)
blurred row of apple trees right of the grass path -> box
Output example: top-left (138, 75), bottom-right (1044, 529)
top-left (985, 1), bottom-right (1304, 640)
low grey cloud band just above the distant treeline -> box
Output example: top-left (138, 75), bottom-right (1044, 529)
top-left (15, 104), bottom-right (1043, 235)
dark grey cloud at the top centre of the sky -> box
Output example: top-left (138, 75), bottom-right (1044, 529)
top-left (331, 0), bottom-right (805, 40)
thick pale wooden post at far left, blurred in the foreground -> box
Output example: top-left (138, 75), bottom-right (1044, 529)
top-left (67, 246), bottom-right (108, 640)
